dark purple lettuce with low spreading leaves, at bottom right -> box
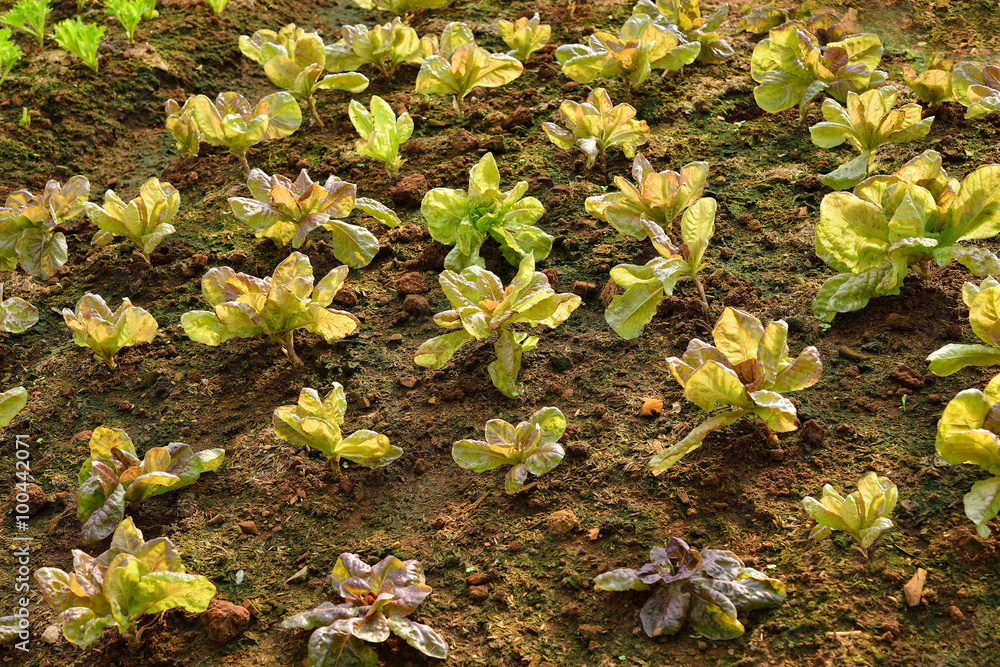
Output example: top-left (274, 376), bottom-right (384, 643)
top-left (594, 537), bottom-right (785, 639)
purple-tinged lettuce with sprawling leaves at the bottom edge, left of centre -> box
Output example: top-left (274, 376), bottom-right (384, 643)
top-left (281, 553), bottom-right (448, 667)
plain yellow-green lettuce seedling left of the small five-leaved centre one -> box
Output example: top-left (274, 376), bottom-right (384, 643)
top-left (271, 382), bottom-right (403, 476)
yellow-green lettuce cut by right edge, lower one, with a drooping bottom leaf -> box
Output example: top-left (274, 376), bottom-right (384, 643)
top-left (934, 375), bottom-right (1000, 538)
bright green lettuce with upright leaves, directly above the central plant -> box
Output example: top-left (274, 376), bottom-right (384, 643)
top-left (420, 153), bottom-right (553, 271)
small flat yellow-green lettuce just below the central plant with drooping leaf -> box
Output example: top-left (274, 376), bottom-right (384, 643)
top-left (451, 408), bottom-right (566, 494)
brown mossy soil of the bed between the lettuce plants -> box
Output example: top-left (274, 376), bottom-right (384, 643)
top-left (0, 0), bottom-right (1000, 667)
